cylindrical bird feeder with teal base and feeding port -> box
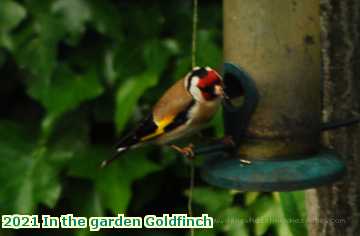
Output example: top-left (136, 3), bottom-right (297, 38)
top-left (202, 0), bottom-right (345, 191)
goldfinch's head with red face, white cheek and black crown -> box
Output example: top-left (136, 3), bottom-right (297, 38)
top-left (185, 67), bottom-right (224, 102)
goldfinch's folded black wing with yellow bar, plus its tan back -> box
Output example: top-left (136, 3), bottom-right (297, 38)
top-left (118, 79), bottom-right (194, 149)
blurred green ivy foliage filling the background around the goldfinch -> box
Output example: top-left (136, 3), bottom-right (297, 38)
top-left (0, 0), bottom-right (306, 236)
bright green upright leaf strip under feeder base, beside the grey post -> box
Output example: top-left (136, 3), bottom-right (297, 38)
top-left (279, 192), bottom-right (307, 236)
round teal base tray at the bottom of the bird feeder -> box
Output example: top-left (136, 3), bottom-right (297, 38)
top-left (202, 150), bottom-right (345, 191)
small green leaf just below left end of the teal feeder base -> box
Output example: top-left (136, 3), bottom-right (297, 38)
top-left (193, 187), bottom-right (233, 215)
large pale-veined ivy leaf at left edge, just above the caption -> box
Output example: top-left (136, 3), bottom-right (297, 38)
top-left (0, 115), bottom-right (88, 214)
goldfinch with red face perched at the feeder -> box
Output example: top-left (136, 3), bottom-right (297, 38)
top-left (101, 66), bottom-right (228, 167)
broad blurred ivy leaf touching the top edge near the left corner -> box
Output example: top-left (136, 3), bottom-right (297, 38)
top-left (13, 0), bottom-right (66, 80)
